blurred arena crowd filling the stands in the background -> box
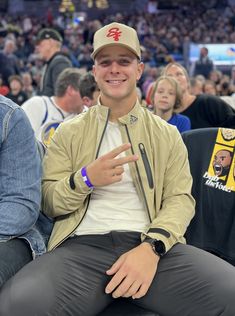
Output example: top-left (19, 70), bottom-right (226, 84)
top-left (0, 0), bottom-right (235, 106)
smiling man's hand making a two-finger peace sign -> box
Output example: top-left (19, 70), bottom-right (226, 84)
top-left (86, 143), bottom-right (138, 187)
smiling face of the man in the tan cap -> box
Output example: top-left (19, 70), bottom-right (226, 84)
top-left (93, 45), bottom-right (143, 110)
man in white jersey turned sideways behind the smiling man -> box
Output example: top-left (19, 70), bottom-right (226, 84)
top-left (22, 68), bottom-right (86, 146)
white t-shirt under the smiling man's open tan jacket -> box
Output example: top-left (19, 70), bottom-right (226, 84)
top-left (75, 122), bottom-right (149, 235)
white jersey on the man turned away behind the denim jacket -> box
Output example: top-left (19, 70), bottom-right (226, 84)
top-left (21, 96), bottom-right (77, 146)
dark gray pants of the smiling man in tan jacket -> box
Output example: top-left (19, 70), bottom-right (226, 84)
top-left (0, 232), bottom-right (235, 316)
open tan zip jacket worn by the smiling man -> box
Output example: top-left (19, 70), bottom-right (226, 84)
top-left (42, 102), bottom-right (195, 251)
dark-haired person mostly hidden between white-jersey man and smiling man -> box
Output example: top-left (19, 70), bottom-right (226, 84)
top-left (79, 72), bottom-right (100, 108)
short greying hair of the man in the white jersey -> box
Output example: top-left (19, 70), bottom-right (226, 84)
top-left (55, 67), bottom-right (81, 97)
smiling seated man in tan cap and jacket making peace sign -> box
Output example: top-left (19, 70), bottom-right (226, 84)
top-left (0, 22), bottom-right (235, 316)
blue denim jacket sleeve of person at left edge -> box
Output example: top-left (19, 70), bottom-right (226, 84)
top-left (0, 108), bottom-right (41, 236)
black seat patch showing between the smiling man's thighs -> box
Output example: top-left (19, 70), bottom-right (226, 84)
top-left (98, 298), bottom-right (160, 316)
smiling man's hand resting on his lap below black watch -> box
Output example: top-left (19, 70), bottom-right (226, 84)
top-left (105, 242), bottom-right (160, 299)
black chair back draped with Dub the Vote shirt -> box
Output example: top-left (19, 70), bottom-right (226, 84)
top-left (182, 128), bottom-right (235, 265)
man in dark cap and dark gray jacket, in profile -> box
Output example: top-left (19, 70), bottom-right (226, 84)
top-left (36, 28), bottom-right (72, 97)
